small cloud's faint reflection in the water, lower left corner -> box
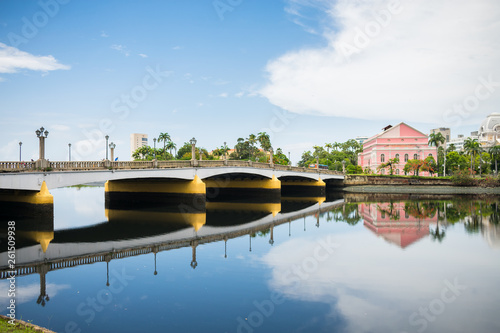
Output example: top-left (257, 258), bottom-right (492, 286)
top-left (0, 280), bottom-right (71, 309)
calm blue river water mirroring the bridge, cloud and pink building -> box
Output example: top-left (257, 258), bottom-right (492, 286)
top-left (0, 187), bottom-right (500, 333)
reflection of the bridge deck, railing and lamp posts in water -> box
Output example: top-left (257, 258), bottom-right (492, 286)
top-left (0, 200), bottom-right (344, 305)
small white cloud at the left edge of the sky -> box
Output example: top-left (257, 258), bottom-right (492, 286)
top-left (0, 43), bottom-right (71, 73)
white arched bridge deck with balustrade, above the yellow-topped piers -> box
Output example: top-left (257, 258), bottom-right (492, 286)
top-left (0, 160), bottom-right (344, 191)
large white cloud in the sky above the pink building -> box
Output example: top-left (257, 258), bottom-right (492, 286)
top-left (260, 0), bottom-right (500, 123)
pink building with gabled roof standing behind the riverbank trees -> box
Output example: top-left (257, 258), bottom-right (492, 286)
top-left (358, 123), bottom-right (437, 176)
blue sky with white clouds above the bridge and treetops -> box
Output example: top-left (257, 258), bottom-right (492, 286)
top-left (0, 0), bottom-right (500, 163)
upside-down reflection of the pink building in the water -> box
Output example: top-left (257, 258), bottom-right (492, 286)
top-left (358, 202), bottom-right (438, 249)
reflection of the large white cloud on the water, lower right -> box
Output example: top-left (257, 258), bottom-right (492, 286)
top-left (262, 232), bottom-right (500, 333)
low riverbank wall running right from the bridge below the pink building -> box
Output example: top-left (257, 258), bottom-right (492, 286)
top-left (342, 185), bottom-right (500, 195)
